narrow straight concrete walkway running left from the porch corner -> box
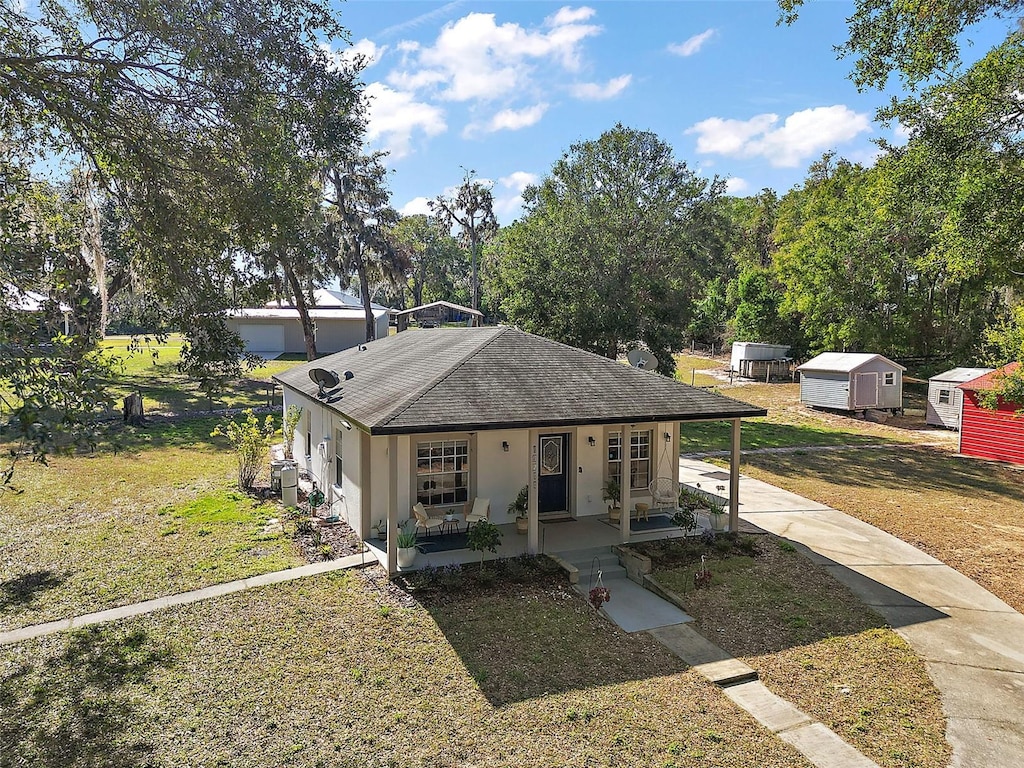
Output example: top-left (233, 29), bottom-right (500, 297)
top-left (0, 554), bottom-right (368, 645)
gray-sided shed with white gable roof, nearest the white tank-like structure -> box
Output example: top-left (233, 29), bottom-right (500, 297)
top-left (797, 352), bottom-right (906, 413)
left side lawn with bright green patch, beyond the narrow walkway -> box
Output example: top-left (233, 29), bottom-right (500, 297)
top-left (0, 418), bottom-right (302, 630)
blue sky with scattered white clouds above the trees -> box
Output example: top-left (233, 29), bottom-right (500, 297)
top-left (335, 0), bottom-right (1007, 223)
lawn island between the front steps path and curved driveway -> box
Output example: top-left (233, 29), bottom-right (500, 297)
top-left (642, 536), bottom-right (950, 768)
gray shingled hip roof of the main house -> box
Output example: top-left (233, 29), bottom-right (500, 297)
top-left (273, 328), bottom-right (767, 434)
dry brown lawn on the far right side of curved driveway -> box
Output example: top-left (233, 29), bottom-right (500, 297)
top-left (743, 446), bottom-right (1024, 610)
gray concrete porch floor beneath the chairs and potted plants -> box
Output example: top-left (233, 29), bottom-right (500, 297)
top-left (366, 509), bottom-right (710, 570)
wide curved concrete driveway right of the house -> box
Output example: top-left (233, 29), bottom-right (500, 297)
top-left (679, 459), bottom-right (1024, 768)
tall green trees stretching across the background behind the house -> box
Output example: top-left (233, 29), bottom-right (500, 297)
top-left (0, 0), bottom-right (1024, 480)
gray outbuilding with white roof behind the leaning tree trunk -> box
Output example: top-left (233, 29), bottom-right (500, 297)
top-left (227, 288), bottom-right (389, 354)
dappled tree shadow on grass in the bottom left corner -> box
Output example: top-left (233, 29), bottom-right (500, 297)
top-left (0, 627), bottom-right (173, 768)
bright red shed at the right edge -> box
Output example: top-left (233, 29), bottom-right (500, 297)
top-left (959, 362), bottom-right (1024, 464)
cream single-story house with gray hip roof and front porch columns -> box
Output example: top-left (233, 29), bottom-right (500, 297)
top-left (273, 327), bottom-right (767, 572)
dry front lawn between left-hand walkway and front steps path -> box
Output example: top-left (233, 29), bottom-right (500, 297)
top-left (0, 564), bottom-right (808, 768)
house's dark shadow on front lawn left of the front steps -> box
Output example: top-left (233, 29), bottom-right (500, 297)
top-left (393, 557), bottom-right (686, 707)
